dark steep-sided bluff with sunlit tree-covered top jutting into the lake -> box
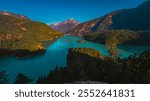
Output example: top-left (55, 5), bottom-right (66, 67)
top-left (67, 48), bottom-right (103, 68)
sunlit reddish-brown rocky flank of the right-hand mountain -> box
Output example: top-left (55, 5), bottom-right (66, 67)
top-left (70, 10), bottom-right (124, 34)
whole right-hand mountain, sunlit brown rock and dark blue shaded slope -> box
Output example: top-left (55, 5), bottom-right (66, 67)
top-left (70, 1), bottom-right (150, 34)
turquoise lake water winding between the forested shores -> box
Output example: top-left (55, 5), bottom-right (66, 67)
top-left (0, 36), bottom-right (150, 83)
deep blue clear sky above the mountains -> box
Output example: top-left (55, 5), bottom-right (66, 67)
top-left (0, 0), bottom-right (146, 24)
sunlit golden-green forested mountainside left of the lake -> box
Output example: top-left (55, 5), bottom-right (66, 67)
top-left (0, 13), bottom-right (63, 56)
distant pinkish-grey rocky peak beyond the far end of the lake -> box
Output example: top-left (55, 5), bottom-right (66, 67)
top-left (50, 18), bottom-right (80, 33)
